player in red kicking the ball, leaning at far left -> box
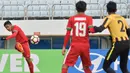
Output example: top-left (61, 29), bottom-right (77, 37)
top-left (2, 21), bottom-right (34, 73)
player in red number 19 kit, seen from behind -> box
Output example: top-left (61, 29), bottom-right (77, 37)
top-left (62, 1), bottom-right (94, 73)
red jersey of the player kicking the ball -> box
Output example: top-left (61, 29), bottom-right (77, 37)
top-left (6, 25), bottom-right (28, 43)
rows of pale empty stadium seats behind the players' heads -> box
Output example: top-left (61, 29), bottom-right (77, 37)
top-left (0, 0), bottom-right (130, 19)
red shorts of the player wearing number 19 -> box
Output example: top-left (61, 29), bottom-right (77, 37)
top-left (63, 43), bottom-right (91, 66)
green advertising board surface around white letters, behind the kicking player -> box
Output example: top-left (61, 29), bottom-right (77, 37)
top-left (0, 50), bottom-right (64, 73)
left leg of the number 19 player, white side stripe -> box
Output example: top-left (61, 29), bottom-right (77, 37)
top-left (61, 45), bottom-right (79, 73)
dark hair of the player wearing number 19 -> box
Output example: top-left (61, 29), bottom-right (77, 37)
top-left (76, 1), bottom-right (87, 12)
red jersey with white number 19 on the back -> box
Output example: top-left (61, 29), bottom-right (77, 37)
top-left (67, 14), bottom-right (92, 43)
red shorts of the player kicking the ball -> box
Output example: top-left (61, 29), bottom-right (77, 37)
top-left (15, 42), bottom-right (30, 58)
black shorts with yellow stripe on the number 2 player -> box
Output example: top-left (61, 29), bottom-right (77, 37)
top-left (105, 40), bottom-right (129, 61)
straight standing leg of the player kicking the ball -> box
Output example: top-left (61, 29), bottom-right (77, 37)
top-left (22, 43), bottom-right (34, 73)
